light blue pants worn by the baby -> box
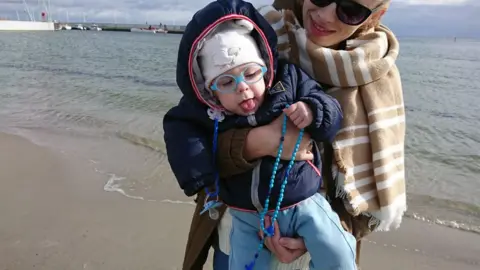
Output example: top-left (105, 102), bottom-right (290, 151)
top-left (229, 193), bottom-right (357, 270)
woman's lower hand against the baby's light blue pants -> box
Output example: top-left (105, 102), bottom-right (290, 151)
top-left (258, 216), bottom-right (307, 263)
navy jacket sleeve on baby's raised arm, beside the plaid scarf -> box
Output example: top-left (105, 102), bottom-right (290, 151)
top-left (289, 64), bottom-right (343, 142)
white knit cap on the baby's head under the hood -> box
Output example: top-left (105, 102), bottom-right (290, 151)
top-left (199, 19), bottom-right (265, 88)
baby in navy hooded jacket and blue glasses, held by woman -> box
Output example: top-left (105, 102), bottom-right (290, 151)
top-left (164, 1), bottom-right (356, 270)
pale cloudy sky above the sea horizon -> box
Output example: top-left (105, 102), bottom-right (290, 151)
top-left (0, 0), bottom-right (480, 37)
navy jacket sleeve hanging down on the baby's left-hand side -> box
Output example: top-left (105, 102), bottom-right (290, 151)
top-left (163, 98), bottom-right (215, 196)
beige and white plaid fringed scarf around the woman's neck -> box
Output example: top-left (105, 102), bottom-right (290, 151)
top-left (259, 6), bottom-right (407, 231)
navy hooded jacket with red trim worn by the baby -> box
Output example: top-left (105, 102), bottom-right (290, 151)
top-left (163, 0), bottom-right (342, 210)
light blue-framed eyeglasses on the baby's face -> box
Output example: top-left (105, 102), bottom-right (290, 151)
top-left (210, 64), bottom-right (267, 93)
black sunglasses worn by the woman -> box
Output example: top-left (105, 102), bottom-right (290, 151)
top-left (310, 0), bottom-right (388, 25)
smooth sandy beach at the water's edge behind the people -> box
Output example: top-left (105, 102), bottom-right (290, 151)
top-left (0, 133), bottom-right (480, 270)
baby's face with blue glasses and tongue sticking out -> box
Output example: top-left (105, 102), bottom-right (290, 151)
top-left (211, 63), bottom-right (267, 116)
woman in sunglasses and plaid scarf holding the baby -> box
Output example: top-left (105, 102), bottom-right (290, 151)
top-left (177, 0), bottom-right (406, 270)
